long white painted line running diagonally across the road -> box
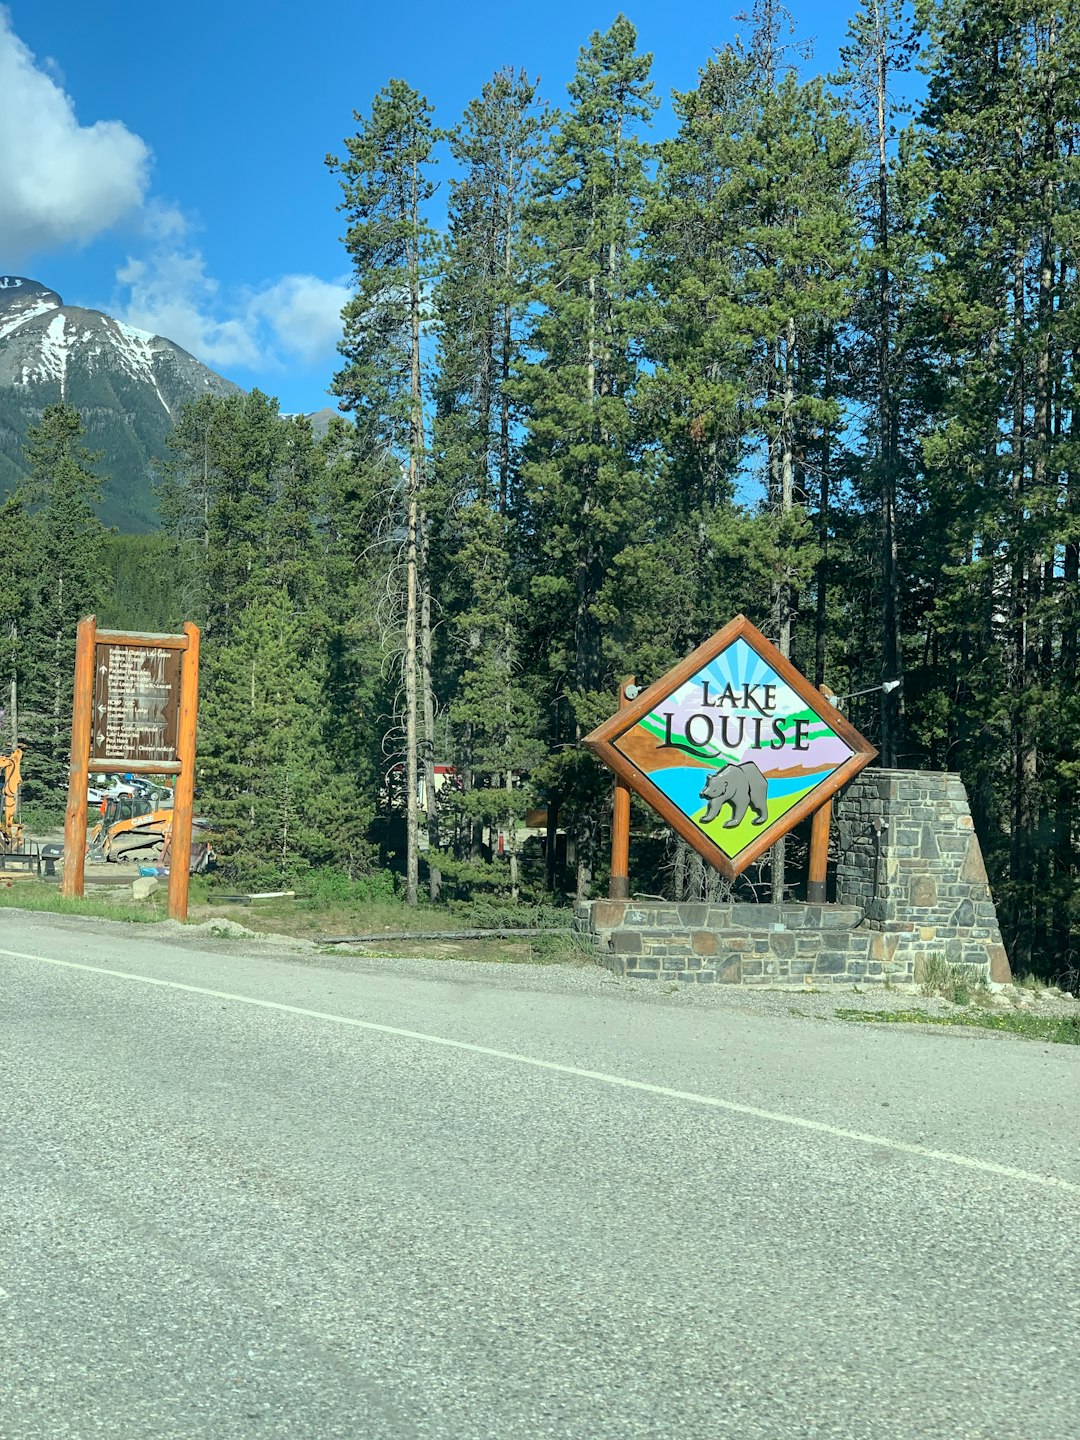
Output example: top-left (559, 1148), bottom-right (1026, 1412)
top-left (0, 949), bottom-right (1080, 1195)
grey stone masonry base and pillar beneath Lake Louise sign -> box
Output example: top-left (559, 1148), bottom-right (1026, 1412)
top-left (575, 769), bottom-right (1009, 985)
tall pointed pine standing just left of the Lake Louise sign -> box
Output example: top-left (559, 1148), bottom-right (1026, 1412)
top-left (514, 16), bottom-right (655, 894)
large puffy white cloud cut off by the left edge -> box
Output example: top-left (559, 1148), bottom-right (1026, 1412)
top-left (0, 6), bottom-right (151, 266)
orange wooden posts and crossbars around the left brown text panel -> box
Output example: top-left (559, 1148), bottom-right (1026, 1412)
top-left (60, 615), bottom-right (200, 920)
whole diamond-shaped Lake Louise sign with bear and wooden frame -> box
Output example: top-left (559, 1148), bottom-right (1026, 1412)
top-left (585, 615), bottom-right (877, 878)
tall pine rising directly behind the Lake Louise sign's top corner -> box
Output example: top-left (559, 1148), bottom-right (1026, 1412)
top-left (696, 25), bottom-right (860, 900)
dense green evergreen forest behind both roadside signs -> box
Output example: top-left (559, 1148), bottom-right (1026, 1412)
top-left (0, 0), bottom-right (1080, 981)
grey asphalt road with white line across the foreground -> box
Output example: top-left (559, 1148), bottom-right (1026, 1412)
top-left (0, 912), bottom-right (1080, 1440)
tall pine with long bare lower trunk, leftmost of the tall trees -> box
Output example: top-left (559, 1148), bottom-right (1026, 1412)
top-left (327, 79), bottom-right (438, 904)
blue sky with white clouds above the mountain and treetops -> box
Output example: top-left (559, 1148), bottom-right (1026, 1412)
top-left (0, 0), bottom-right (875, 410)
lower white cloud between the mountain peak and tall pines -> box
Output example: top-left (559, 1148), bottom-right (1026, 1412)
top-left (112, 233), bottom-right (350, 373)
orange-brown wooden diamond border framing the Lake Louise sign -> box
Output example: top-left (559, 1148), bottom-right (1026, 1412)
top-left (583, 615), bottom-right (877, 880)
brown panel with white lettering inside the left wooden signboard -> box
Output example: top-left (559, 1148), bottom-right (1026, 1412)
top-left (91, 641), bottom-right (180, 765)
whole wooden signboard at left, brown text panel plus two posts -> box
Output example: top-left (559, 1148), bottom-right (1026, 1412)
top-left (60, 615), bottom-right (199, 920)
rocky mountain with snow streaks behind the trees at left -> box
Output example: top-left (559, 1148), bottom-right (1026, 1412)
top-left (0, 275), bottom-right (238, 530)
